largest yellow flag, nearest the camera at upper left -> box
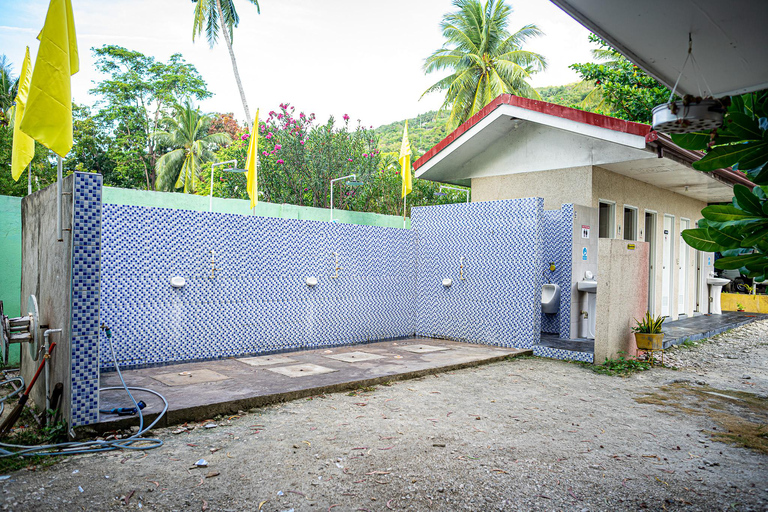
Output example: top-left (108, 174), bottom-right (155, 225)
top-left (20, 0), bottom-right (80, 157)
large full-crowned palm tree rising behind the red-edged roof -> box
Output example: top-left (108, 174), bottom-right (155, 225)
top-left (422, 0), bottom-right (547, 126)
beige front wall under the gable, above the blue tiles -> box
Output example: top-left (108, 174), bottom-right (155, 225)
top-left (472, 165), bottom-right (592, 210)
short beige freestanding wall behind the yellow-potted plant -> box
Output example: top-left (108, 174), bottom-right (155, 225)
top-left (595, 238), bottom-right (648, 363)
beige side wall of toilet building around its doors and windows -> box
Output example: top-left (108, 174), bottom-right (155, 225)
top-left (591, 167), bottom-right (711, 320)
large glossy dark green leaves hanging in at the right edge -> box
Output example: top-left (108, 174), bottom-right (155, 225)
top-left (672, 91), bottom-right (768, 281)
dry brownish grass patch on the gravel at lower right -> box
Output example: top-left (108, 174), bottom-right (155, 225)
top-left (635, 383), bottom-right (768, 455)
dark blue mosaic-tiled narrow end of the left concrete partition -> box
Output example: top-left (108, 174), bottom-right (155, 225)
top-left (70, 173), bottom-right (101, 427)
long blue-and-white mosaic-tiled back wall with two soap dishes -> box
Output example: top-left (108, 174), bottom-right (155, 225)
top-left (100, 205), bottom-right (416, 368)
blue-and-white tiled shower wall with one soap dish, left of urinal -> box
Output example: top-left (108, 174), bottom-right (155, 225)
top-left (411, 198), bottom-right (543, 348)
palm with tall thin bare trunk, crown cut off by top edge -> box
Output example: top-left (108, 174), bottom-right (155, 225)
top-left (192, 0), bottom-right (261, 128)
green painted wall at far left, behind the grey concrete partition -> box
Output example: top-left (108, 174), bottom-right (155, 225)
top-left (0, 196), bottom-right (26, 365)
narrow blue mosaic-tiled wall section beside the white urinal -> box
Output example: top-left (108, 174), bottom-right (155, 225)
top-left (541, 204), bottom-right (573, 340)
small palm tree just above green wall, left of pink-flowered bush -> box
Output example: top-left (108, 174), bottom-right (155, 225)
top-left (155, 99), bottom-right (232, 193)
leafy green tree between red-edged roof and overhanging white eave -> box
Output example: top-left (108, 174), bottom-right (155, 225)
top-left (570, 35), bottom-right (670, 123)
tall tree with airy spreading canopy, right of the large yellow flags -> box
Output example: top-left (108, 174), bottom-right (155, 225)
top-left (91, 45), bottom-right (211, 190)
